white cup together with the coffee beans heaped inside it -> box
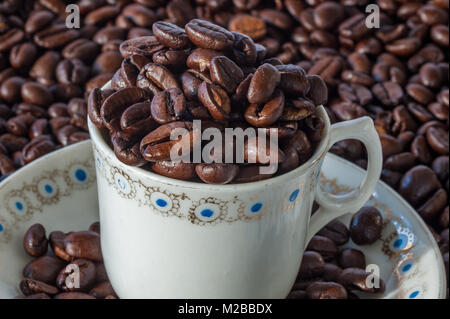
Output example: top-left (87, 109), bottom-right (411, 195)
top-left (88, 19), bottom-right (382, 298)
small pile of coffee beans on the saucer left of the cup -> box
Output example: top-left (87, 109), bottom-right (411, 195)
top-left (19, 222), bottom-right (117, 299)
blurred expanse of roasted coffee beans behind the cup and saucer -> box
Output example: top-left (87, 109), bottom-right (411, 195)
top-left (0, 0), bottom-right (449, 300)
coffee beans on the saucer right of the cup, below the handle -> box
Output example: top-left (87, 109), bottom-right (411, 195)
top-left (288, 206), bottom-right (386, 299)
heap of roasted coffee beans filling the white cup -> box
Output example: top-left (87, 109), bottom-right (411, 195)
top-left (88, 19), bottom-right (328, 184)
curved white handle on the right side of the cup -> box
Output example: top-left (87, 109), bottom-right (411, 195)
top-left (306, 116), bottom-right (383, 243)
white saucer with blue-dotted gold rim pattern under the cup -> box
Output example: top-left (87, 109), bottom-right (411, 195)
top-left (0, 141), bottom-right (446, 299)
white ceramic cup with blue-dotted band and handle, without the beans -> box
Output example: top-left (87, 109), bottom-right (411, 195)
top-left (89, 83), bottom-right (382, 298)
